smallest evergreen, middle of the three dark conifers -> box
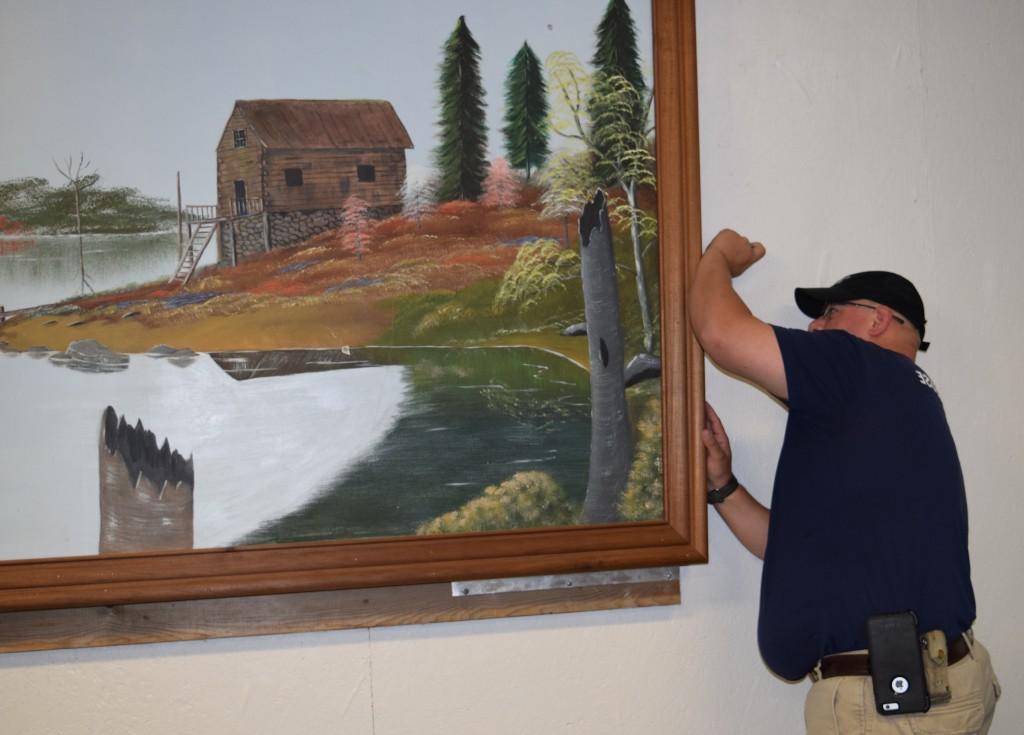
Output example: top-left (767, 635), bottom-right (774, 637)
top-left (502, 42), bottom-right (549, 181)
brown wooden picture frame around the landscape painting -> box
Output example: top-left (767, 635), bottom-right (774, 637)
top-left (0, 0), bottom-right (708, 640)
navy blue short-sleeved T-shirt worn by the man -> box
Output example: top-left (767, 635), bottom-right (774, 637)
top-left (758, 327), bottom-right (975, 680)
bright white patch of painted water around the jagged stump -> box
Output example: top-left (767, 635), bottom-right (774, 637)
top-left (0, 354), bottom-right (407, 559)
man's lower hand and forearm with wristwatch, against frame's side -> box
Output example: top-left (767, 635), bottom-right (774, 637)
top-left (700, 403), bottom-right (769, 559)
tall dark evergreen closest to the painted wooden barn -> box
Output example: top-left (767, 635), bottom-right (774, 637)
top-left (434, 15), bottom-right (487, 202)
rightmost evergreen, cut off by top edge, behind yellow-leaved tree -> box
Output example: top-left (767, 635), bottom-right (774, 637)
top-left (587, 0), bottom-right (647, 185)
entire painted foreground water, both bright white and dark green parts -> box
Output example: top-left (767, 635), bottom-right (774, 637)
top-left (0, 341), bottom-right (590, 559)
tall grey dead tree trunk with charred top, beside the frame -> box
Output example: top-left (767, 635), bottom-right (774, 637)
top-left (580, 191), bottom-right (633, 523)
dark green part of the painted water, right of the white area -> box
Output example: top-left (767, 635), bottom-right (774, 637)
top-left (245, 348), bottom-right (590, 543)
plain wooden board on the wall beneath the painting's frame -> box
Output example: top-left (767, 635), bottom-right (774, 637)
top-left (0, 575), bottom-right (680, 653)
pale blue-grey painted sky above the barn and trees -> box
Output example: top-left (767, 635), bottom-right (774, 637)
top-left (0, 0), bottom-right (651, 204)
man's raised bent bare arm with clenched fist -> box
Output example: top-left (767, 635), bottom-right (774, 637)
top-left (689, 229), bottom-right (788, 398)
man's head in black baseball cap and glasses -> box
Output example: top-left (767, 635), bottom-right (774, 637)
top-left (795, 270), bottom-right (928, 358)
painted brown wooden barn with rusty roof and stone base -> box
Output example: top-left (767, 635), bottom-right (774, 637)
top-left (217, 99), bottom-right (413, 262)
